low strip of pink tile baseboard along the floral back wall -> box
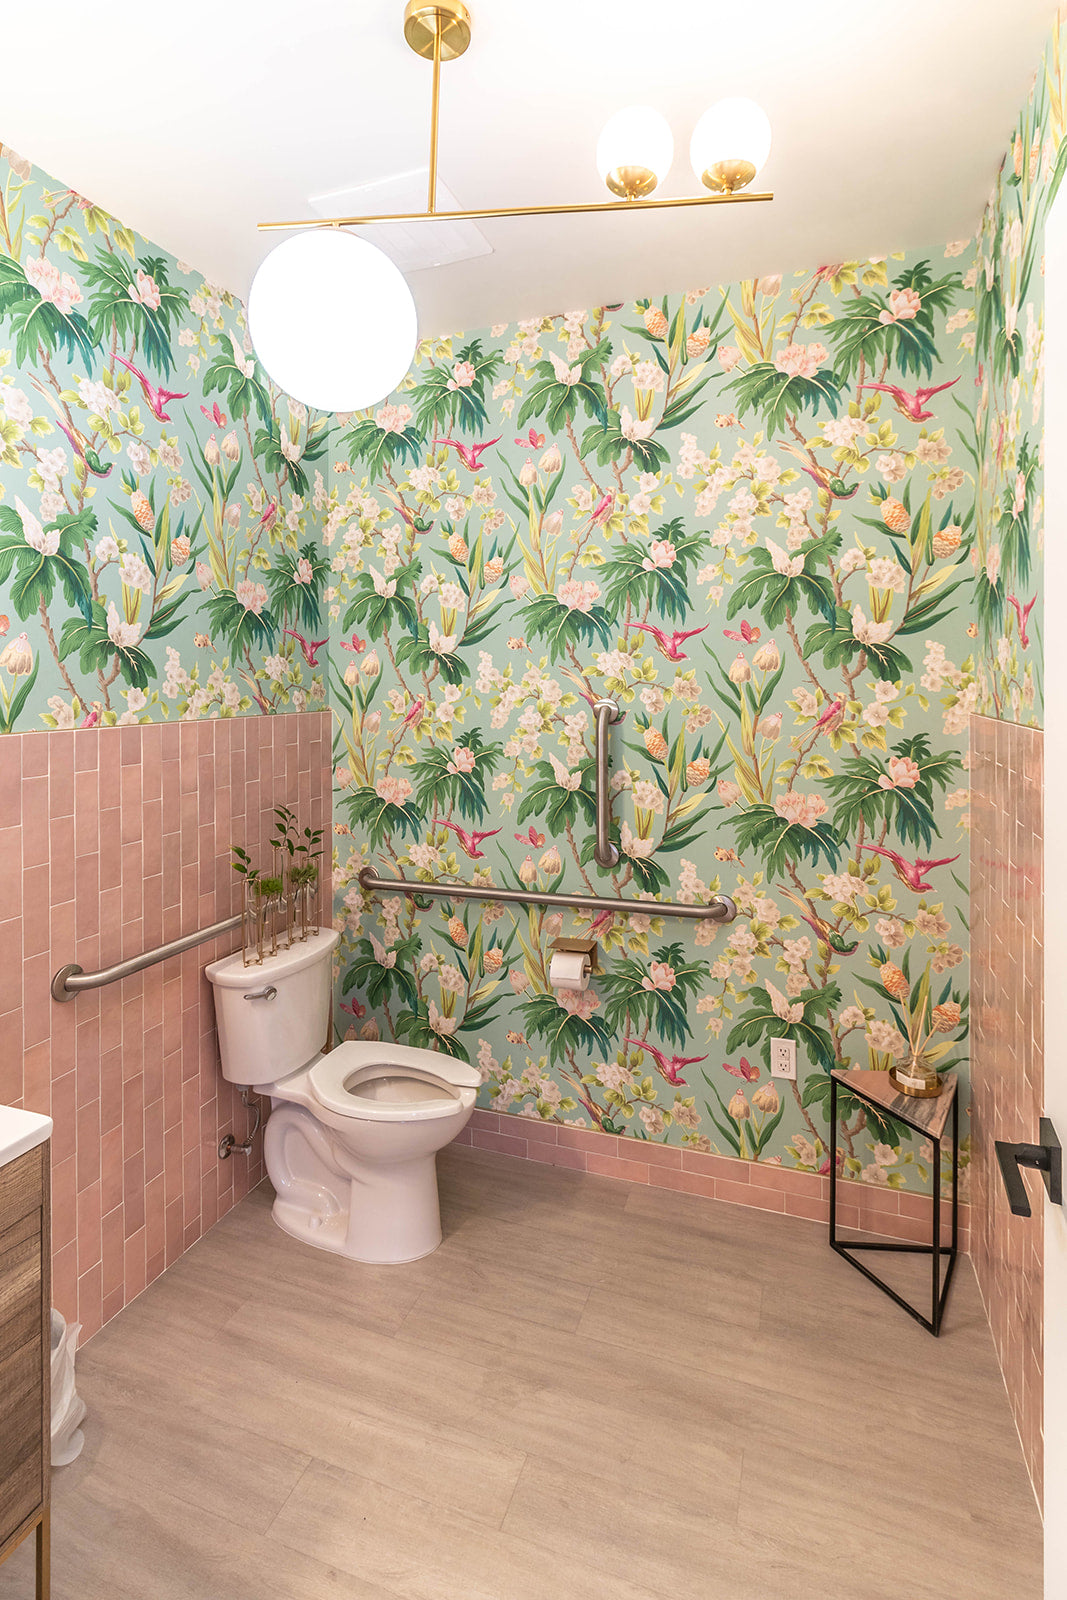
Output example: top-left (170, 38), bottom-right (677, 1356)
top-left (456, 1110), bottom-right (971, 1250)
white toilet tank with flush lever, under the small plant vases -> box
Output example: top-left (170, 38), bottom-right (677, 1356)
top-left (206, 928), bottom-right (341, 1083)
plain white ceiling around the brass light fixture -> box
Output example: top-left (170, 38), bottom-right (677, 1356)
top-left (0, 0), bottom-right (1053, 333)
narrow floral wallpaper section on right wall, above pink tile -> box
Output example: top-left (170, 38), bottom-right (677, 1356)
top-left (965, 14), bottom-right (1067, 723)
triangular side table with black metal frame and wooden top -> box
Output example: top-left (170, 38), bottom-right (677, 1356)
top-left (830, 1067), bottom-right (960, 1338)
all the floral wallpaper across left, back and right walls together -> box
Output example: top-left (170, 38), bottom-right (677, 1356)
top-left (14, 46), bottom-right (1067, 1187)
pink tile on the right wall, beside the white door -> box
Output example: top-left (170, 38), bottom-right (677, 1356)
top-left (971, 717), bottom-right (1045, 1506)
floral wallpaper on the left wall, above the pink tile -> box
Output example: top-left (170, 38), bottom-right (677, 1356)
top-left (0, 147), bottom-right (330, 733)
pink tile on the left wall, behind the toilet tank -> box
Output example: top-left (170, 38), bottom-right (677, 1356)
top-left (0, 712), bottom-right (331, 1338)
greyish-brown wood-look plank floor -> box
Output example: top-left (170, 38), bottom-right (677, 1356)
top-left (0, 1147), bottom-right (1041, 1600)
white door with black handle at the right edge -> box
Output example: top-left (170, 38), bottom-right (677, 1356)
top-left (1043, 190), bottom-right (1067, 1600)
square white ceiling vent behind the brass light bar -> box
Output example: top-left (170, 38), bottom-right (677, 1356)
top-left (307, 166), bottom-right (493, 274)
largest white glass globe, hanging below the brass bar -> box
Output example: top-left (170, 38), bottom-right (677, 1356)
top-left (248, 229), bottom-right (419, 411)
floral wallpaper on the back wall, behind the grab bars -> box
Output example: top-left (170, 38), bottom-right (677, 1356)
top-left (323, 249), bottom-right (976, 1187)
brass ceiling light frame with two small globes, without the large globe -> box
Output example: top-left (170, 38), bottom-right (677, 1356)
top-left (259, 0), bottom-right (774, 232)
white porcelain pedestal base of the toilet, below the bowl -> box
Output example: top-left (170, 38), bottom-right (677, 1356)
top-left (264, 1104), bottom-right (454, 1266)
